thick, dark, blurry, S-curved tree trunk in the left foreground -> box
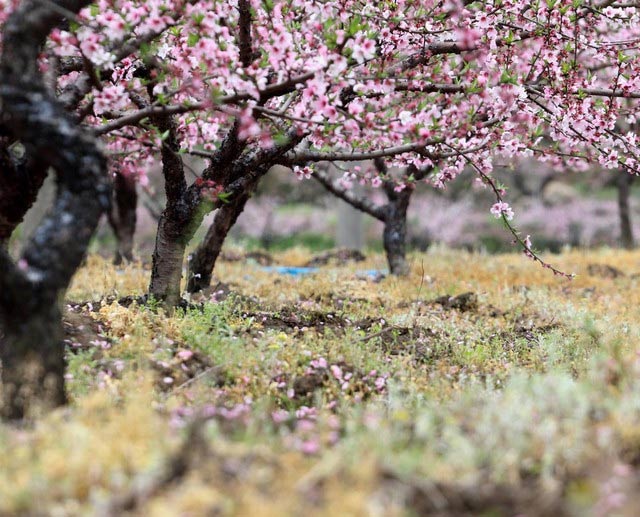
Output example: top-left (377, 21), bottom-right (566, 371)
top-left (0, 0), bottom-right (110, 419)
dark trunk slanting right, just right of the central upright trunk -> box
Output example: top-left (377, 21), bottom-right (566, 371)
top-left (187, 193), bottom-right (250, 293)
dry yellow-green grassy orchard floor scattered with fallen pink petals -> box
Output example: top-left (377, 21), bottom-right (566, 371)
top-left (0, 249), bottom-right (640, 515)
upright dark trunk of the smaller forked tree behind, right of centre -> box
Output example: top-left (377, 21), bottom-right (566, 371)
top-left (382, 183), bottom-right (413, 276)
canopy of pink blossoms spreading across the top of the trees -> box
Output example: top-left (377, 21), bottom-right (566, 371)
top-left (0, 0), bottom-right (640, 270)
